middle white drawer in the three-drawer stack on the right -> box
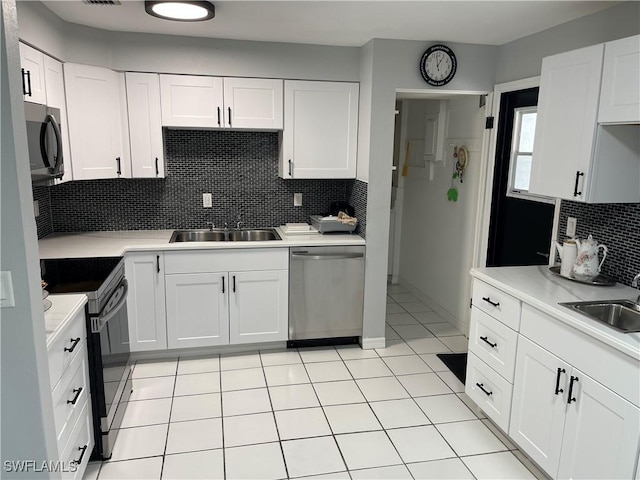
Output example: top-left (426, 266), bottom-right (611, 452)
top-left (469, 307), bottom-right (518, 383)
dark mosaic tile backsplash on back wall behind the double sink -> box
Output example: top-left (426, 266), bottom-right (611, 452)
top-left (41, 129), bottom-right (367, 237)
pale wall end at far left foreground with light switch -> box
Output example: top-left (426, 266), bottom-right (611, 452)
top-left (0, 0), bottom-right (59, 478)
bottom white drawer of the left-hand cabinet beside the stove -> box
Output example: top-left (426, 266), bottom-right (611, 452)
top-left (60, 402), bottom-right (94, 480)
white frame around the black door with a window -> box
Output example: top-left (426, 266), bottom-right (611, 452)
top-left (472, 76), bottom-right (560, 268)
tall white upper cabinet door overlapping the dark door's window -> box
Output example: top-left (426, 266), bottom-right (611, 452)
top-left (529, 44), bottom-right (604, 201)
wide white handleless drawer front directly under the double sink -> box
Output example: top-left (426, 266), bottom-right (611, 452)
top-left (164, 248), bottom-right (289, 275)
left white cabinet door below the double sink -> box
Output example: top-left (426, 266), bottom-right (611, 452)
top-left (166, 272), bottom-right (229, 348)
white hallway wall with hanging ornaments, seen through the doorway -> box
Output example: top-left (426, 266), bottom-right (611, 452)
top-left (400, 95), bottom-right (485, 332)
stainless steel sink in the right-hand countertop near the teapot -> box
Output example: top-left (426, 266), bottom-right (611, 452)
top-left (560, 300), bottom-right (640, 333)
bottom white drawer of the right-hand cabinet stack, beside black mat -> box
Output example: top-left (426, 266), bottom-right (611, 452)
top-left (465, 352), bottom-right (513, 432)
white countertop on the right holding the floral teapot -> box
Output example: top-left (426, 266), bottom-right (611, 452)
top-left (471, 265), bottom-right (640, 359)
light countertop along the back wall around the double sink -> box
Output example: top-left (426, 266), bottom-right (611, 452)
top-left (38, 227), bottom-right (365, 258)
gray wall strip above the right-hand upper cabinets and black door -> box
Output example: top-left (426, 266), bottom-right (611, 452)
top-left (495, 2), bottom-right (640, 83)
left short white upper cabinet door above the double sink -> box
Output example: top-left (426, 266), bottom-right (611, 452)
top-left (160, 75), bottom-right (223, 128)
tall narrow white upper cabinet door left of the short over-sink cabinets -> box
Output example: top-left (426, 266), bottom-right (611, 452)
top-left (125, 72), bottom-right (164, 178)
